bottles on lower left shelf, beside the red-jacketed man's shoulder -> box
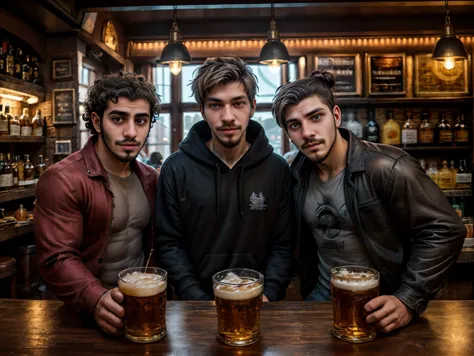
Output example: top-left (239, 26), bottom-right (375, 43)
top-left (0, 153), bottom-right (49, 190)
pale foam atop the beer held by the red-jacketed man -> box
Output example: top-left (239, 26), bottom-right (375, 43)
top-left (118, 272), bottom-right (166, 297)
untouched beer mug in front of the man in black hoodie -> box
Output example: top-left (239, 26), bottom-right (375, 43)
top-left (212, 268), bottom-right (263, 346)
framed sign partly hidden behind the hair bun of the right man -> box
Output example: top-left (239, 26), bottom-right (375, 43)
top-left (314, 54), bottom-right (362, 96)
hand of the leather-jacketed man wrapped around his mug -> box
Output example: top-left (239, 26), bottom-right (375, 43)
top-left (364, 295), bottom-right (413, 333)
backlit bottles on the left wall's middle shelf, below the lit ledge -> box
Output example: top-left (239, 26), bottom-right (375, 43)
top-left (0, 105), bottom-right (44, 136)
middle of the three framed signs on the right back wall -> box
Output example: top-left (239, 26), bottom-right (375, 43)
top-left (367, 53), bottom-right (406, 95)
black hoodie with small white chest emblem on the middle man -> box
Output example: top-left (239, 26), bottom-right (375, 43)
top-left (155, 120), bottom-right (294, 300)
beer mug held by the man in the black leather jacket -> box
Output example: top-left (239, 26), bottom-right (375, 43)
top-left (331, 266), bottom-right (380, 343)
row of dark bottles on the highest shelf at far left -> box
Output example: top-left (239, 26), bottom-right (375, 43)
top-left (0, 36), bottom-right (41, 84)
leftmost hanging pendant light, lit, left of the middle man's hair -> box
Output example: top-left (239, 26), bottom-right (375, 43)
top-left (160, 6), bottom-right (191, 75)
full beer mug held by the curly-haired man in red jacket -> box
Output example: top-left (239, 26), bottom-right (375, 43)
top-left (118, 267), bottom-right (167, 343)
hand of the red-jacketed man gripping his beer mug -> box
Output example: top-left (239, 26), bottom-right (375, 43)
top-left (94, 288), bottom-right (125, 335)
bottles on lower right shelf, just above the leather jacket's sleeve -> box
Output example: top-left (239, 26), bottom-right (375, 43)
top-left (420, 159), bottom-right (472, 189)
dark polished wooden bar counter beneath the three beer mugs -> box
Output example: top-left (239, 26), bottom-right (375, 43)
top-left (0, 299), bottom-right (474, 356)
